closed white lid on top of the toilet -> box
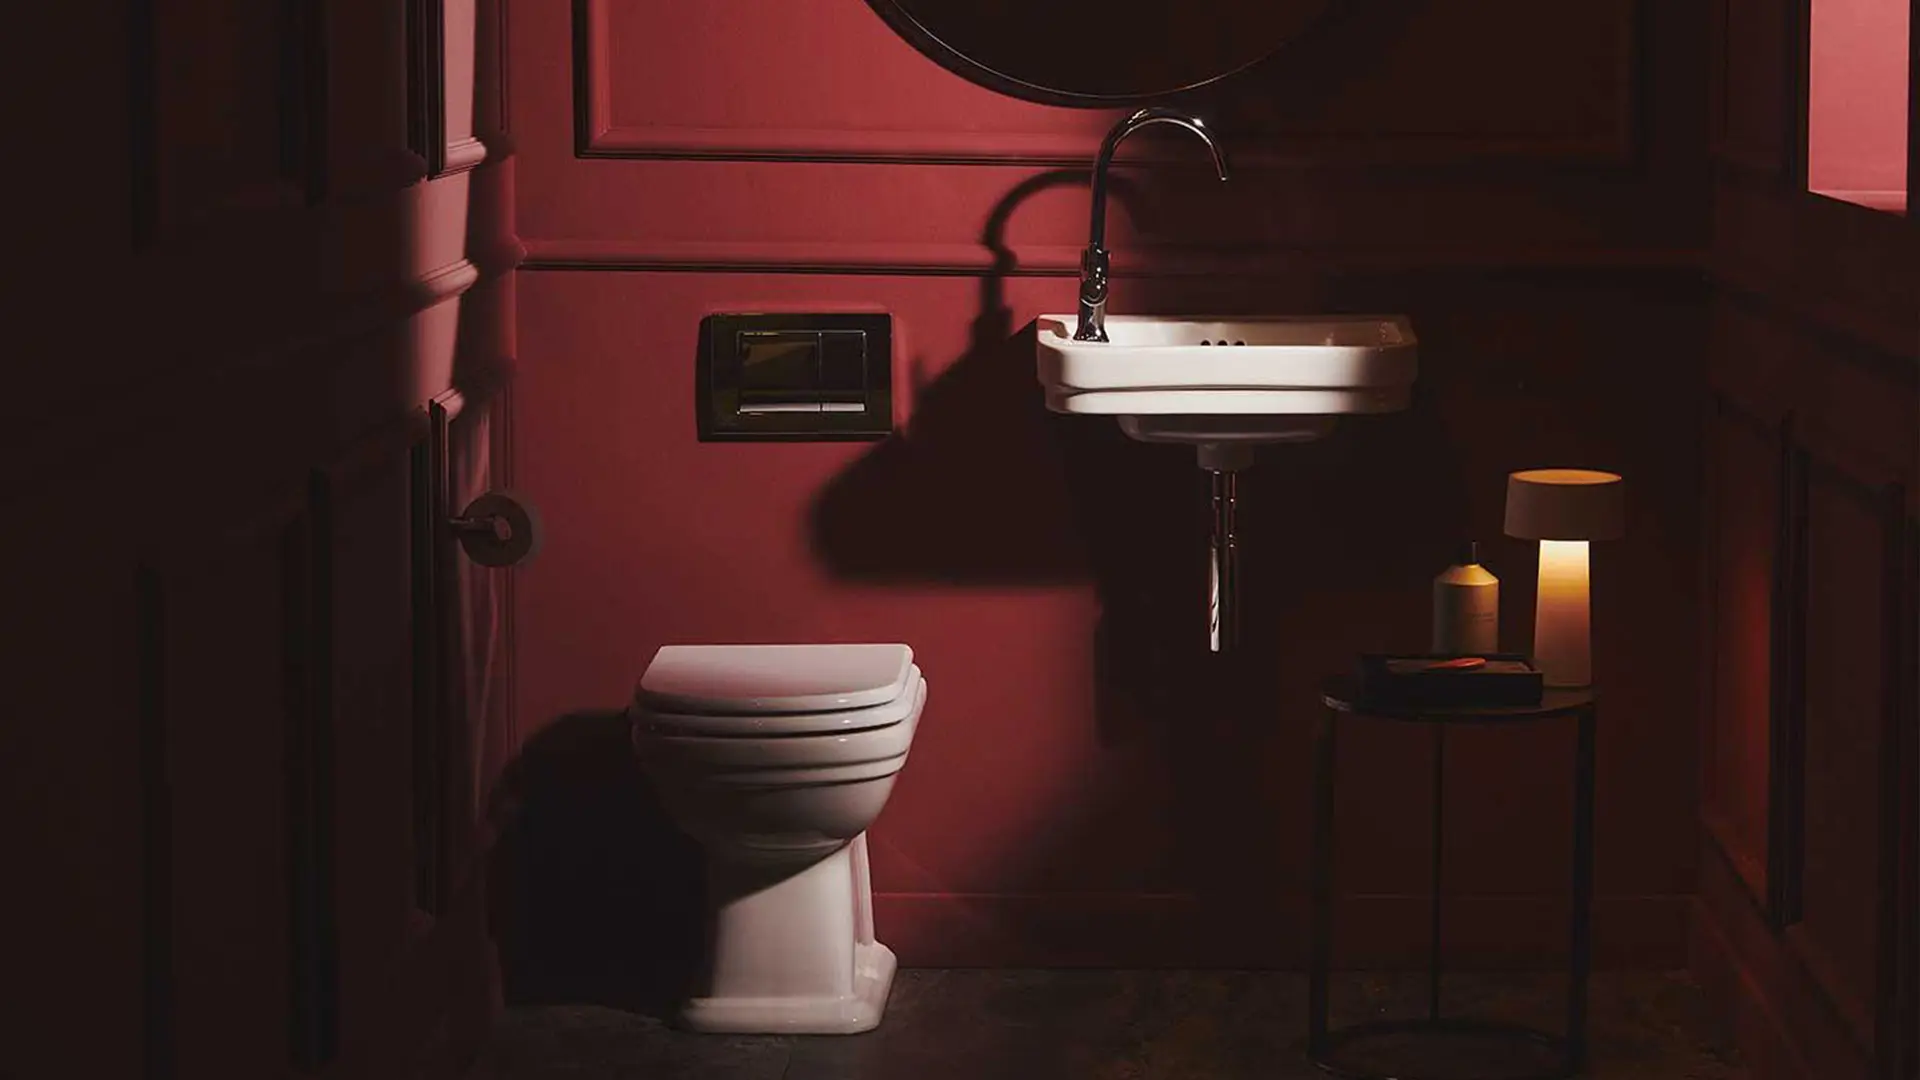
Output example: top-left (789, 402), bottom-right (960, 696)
top-left (634, 646), bottom-right (914, 715)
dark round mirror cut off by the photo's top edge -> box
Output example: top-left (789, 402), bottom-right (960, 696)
top-left (868, 0), bottom-right (1334, 108)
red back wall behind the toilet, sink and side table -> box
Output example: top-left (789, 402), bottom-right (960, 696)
top-left (509, 0), bottom-right (1705, 965)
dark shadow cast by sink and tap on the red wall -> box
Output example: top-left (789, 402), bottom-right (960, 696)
top-left (812, 171), bottom-right (1467, 909)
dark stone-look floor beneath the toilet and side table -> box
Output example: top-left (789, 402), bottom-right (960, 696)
top-left (474, 970), bottom-right (1745, 1080)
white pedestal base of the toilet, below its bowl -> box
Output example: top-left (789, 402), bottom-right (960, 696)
top-left (678, 834), bottom-right (897, 1036)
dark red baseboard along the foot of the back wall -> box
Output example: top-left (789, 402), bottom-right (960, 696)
top-left (874, 894), bottom-right (1692, 970)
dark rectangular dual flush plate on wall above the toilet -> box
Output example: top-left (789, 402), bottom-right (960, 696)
top-left (693, 313), bottom-right (893, 442)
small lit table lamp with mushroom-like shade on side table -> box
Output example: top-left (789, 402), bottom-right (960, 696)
top-left (1505, 469), bottom-right (1626, 688)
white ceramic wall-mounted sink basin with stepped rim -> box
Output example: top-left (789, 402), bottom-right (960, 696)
top-left (1037, 315), bottom-right (1419, 444)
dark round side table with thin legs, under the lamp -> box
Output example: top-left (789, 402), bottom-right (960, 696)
top-left (1308, 675), bottom-right (1599, 1080)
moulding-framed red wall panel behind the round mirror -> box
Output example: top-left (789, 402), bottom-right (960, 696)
top-left (572, 0), bottom-right (1642, 167)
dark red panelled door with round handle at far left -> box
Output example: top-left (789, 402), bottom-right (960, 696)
top-left (0, 0), bottom-right (516, 1080)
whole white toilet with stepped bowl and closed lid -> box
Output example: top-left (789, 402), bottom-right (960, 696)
top-left (630, 646), bottom-right (927, 1034)
